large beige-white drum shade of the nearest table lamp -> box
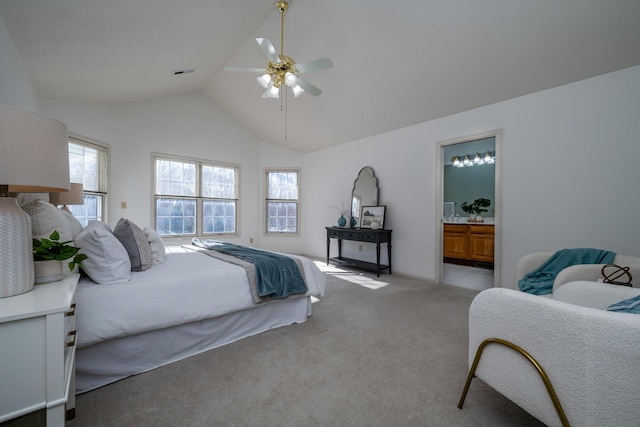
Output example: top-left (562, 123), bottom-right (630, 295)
top-left (0, 105), bottom-right (69, 193)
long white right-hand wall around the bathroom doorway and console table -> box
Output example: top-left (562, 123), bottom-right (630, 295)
top-left (303, 67), bottom-right (640, 286)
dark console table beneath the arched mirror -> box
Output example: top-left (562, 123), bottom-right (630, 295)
top-left (326, 227), bottom-right (391, 277)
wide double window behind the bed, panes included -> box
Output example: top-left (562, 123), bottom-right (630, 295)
top-left (153, 154), bottom-right (240, 236)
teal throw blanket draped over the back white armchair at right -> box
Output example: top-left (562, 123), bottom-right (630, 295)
top-left (518, 248), bottom-right (616, 295)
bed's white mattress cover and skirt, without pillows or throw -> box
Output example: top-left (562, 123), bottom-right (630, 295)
top-left (76, 245), bottom-right (326, 394)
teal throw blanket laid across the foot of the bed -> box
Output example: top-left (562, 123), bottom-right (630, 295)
top-left (191, 238), bottom-right (307, 298)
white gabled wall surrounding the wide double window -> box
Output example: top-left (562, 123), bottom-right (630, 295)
top-left (40, 93), bottom-right (261, 244)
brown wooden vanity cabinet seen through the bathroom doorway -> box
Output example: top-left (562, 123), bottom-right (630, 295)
top-left (443, 224), bottom-right (494, 262)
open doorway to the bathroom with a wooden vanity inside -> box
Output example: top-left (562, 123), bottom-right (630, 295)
top-left (435, 130), bottom-right (502, 289)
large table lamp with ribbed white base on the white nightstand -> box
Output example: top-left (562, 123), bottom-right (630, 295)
top-left (0, 105), bottom-right (69, 298)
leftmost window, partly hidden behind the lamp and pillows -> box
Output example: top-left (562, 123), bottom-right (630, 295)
top-left (69, 136), bottom-right (109, 226)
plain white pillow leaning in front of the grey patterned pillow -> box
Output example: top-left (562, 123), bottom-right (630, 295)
top-left (76, 221), bottom-right (131, 285)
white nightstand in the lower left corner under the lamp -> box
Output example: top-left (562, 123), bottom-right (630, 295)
top-left (0, 274), bottom-right (80, 427)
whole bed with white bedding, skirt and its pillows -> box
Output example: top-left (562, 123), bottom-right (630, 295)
top-left (17, 202), bottom-right (326, 393)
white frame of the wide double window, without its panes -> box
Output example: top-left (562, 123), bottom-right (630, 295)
top-left (151, 152), bottom-right (240, 239)
